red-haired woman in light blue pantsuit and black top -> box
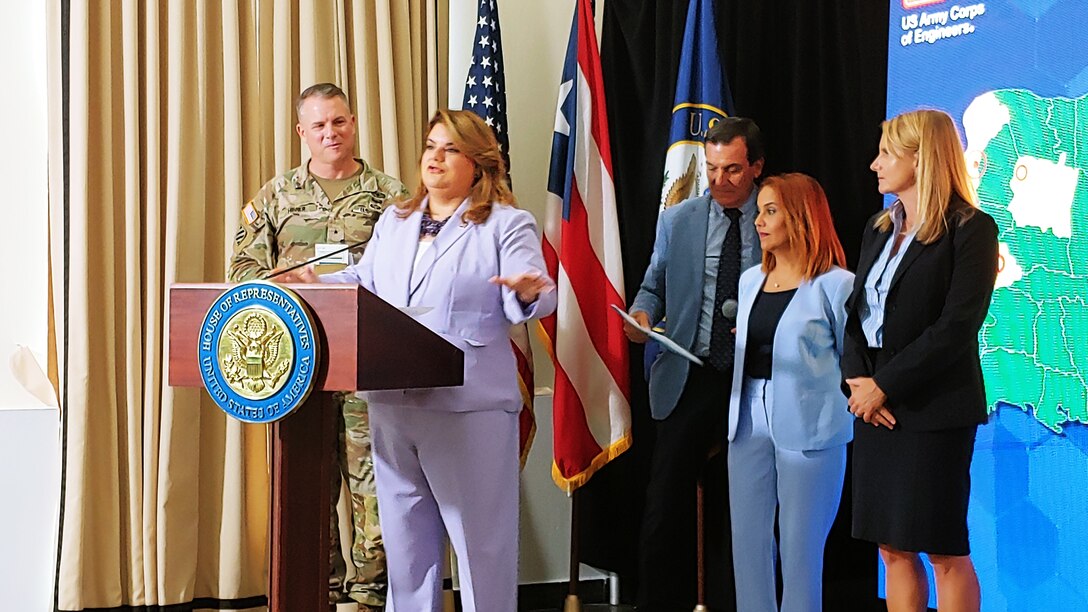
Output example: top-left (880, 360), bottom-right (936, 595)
top-left (729, 174), bottom-right (854, 612)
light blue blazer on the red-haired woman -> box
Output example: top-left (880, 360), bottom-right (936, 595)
top-left (729, 266), bottom-right (854, 451)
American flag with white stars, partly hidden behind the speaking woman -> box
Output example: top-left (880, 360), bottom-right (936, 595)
top-left (461, 0), bottom-right (536, 467)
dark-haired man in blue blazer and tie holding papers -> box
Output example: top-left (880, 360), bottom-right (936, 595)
top-left (625, 118), bottom-right (764, 611)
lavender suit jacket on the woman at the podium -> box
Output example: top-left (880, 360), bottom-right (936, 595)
top-left (321, 200), bottom-right (556, 413)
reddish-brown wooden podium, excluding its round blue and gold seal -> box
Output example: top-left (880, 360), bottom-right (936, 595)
top-left (169, 283), bottom-right (465, 612)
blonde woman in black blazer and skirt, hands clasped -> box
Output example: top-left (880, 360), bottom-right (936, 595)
top-left (842, 110), bottom-right (998, 612)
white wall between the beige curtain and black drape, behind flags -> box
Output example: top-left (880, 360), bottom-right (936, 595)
top-left (448, 0), bottom-right (604, 584)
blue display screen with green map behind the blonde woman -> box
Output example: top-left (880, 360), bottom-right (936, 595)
top-left (874, 0), bottom-right (1088, 612)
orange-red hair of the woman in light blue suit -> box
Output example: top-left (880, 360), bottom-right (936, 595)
top-left (759, 172), bottom-right (846, 280)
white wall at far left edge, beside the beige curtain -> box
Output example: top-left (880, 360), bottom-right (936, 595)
top-left (0, 1), bottom-right (60, 612)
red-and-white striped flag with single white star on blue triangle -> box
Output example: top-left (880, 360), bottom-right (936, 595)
top-left (543, 0), bottom-right (631, 493)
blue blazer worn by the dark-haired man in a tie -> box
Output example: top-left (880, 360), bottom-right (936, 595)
top-left (630, 195), bottom-right (759, 420)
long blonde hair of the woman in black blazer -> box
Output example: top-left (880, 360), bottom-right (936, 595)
top-left (875, 109), bottom-right (978, 244)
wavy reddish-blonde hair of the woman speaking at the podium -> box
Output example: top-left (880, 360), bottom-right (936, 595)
top-left (395, 109), bottom-right (518, 223)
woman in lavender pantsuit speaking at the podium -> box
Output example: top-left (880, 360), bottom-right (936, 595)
top-left (289, 110), bottom-right (556, 612)
